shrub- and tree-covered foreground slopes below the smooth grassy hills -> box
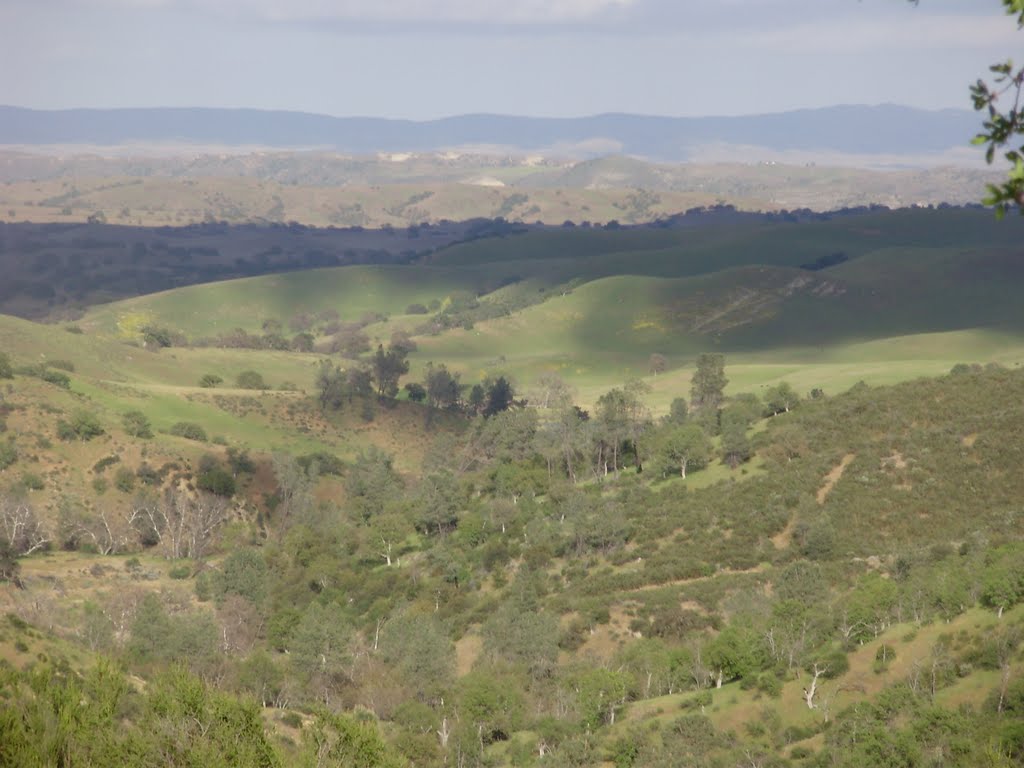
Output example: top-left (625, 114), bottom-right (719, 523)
top-left (0, 362), bottom-right (1024, 766)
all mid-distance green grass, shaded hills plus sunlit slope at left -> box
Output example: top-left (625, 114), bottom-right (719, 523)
top-left (6, 204), bottom-right (1024, 505)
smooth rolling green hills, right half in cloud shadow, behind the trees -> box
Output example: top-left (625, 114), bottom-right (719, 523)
top-left (74, 204), bottom-right (1024, 408)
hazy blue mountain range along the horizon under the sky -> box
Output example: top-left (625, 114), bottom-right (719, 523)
top-left (0, 104), bottom-right (979, 162)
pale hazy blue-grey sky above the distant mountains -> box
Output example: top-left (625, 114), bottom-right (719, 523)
top-left (0, 0), bottom-right (1024, 119)
